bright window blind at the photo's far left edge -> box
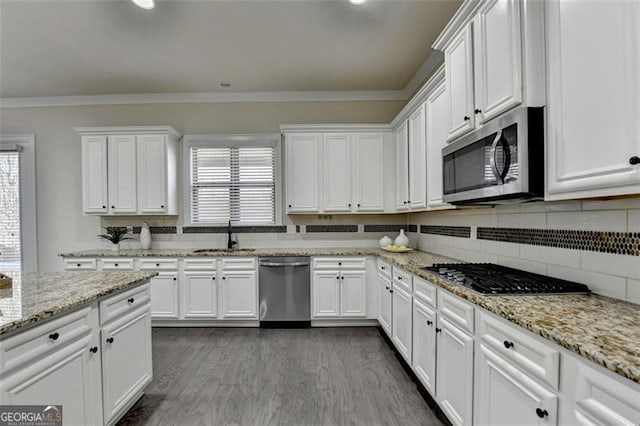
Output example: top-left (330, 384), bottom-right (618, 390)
top-left (0, 150), bottom-right (22, 272)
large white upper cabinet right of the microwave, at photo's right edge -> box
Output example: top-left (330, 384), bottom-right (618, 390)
top-left (545, 0), bottom-right (640, 200)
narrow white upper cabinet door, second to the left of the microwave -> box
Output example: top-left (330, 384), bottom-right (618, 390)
top-left (409, 104), bottom-right (427, 209)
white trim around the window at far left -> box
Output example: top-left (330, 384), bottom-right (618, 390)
top-left (0, 134), bottom-right (38, 272)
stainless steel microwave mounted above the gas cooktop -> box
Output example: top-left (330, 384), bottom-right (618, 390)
top-left (442, 107), bottom-right (544, 205)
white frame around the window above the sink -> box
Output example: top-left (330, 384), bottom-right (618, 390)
top-left (182, 133), bottom-right (282, 226)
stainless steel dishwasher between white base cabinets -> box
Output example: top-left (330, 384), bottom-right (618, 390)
top-left (259, 257), bottom-right (311, 327)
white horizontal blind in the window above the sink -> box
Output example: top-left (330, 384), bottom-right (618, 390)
top-left (190, 146), bottom-right (276, 224)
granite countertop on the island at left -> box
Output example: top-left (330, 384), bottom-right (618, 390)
top-left (0, 272), bottom-right (157, 338)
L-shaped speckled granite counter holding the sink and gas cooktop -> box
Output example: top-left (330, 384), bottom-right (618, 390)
top-left (62, 248), bottom-right (640, 383)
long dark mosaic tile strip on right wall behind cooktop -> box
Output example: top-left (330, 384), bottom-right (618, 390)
top-left (478, 227), bottom-right (640, 256)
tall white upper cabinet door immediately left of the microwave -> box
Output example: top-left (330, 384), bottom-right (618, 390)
top-left (425, 81), bottom-right (451, 209)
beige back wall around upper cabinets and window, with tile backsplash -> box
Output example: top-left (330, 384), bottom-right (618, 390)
top-left (0, 101), bottom-right (404, 271)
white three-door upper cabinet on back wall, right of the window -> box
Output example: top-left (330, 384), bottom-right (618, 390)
top-left (281, 125), bottom-right (394, 214)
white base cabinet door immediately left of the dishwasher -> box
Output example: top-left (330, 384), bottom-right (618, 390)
top-left (220, 270), bottom-right (258, 319)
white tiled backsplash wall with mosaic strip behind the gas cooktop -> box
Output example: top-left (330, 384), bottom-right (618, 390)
top-left (408, 198), bottom-right (640, 303)
